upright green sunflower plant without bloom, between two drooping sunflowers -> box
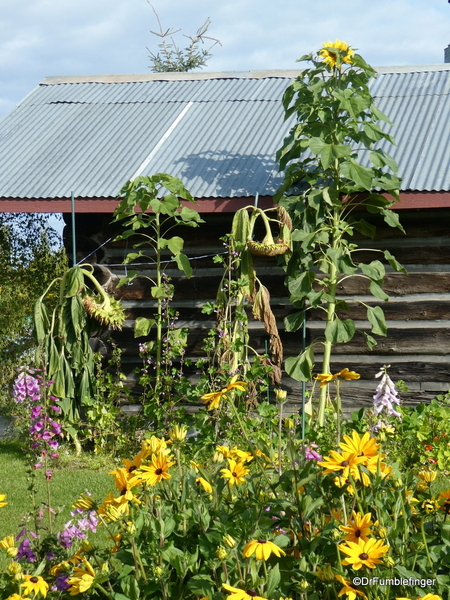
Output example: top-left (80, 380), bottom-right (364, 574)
top-left (114, 173), bottom-right (204, 426)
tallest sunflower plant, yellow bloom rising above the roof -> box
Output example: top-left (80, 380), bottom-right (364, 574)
top-left (275, 44), bottom-right (405, 424)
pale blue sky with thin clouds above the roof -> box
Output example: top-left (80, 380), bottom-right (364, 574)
top-left (0, 0), bottom-right (450, 118)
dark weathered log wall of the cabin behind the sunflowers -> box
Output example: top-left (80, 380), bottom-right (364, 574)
top-left (65, 208), bottom-right (450, 410)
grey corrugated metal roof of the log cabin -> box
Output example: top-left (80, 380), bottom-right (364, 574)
top-left (0, 65), bottom-right (450, 198)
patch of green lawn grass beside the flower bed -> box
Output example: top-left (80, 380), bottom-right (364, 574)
top-left (0, 441), bottom-right (116, 539)
